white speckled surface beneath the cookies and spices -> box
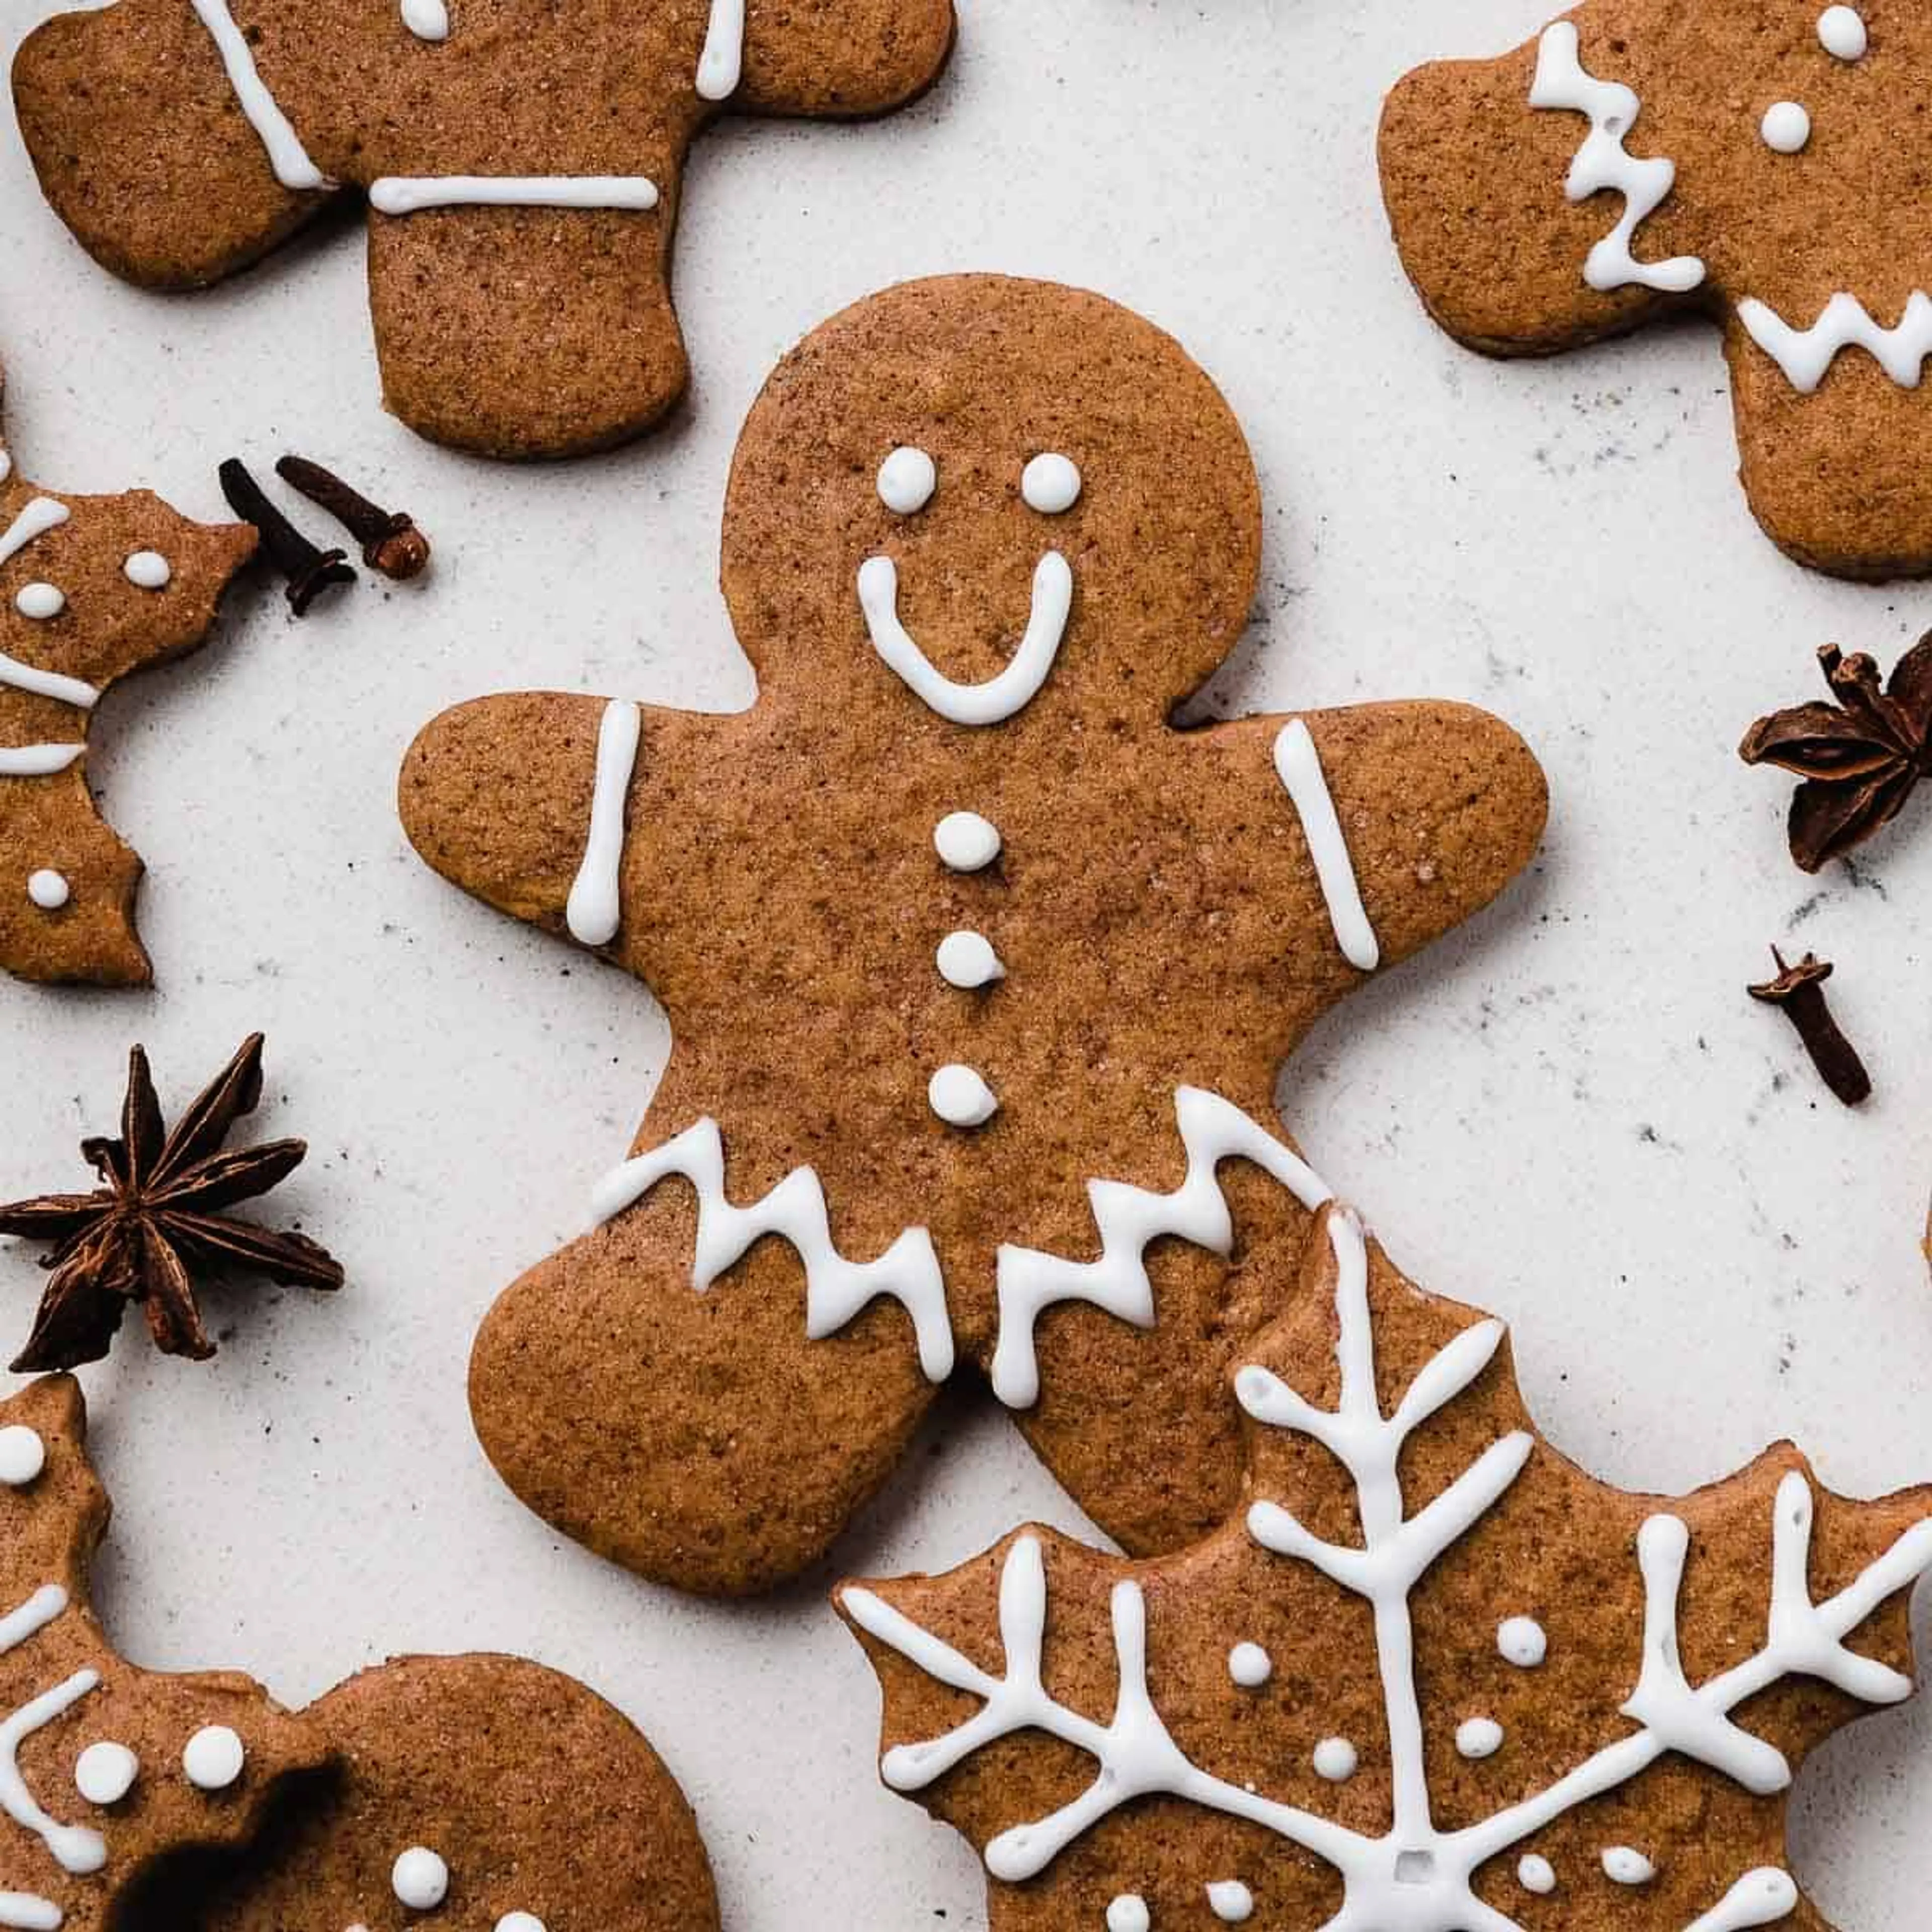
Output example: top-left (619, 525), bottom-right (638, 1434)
top-left (0, 0), bottom-right (1932, 1932)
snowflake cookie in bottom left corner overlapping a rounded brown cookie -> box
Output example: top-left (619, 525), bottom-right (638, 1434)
top-left (0, 1376), bottom-right (325, 1932)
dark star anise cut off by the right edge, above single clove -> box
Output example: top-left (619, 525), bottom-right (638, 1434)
top-left (1737, 632), bottom-right (1932, 871)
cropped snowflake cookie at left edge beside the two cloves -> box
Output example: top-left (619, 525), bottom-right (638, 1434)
top-left (0, 371), bottom-right (255, 985)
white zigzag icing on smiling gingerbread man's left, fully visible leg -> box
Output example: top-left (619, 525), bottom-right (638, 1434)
top-left (591, 1118), bottom-right (954, 1382)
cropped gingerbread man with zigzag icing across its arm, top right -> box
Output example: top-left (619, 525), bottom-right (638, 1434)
top-left (1382, 0), bottom-right (1932, 578)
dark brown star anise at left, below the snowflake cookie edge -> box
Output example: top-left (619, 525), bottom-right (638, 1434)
top-left (0, 1033), bottom-right (342, 1374)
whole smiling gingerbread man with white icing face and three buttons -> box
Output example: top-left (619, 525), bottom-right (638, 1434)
top-left (400, 276), bottom-right (1544, 1592)
